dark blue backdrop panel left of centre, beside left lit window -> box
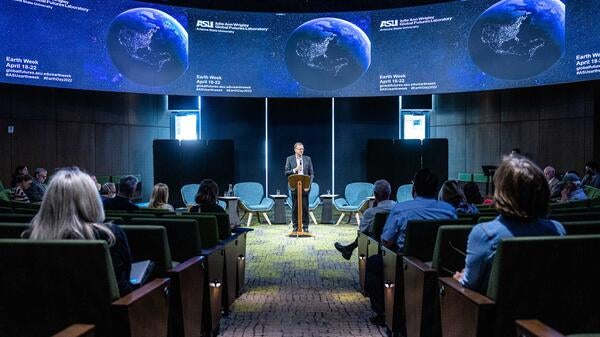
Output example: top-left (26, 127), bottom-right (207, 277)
top-left (198, 97), bottom-right (265, 186)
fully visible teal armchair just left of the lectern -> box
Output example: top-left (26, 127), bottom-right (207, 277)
top-left (233, 182), bottom-right (275, 226)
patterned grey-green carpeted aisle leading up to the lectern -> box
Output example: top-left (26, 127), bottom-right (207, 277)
top-left (219, 225), bottom-right (385, 337)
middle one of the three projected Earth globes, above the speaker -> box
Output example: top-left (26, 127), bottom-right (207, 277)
top-left (285, 18), bottom-right (371, 90)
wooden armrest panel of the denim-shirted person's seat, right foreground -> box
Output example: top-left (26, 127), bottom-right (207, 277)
top-left (438, 277), bottom-right (496, 337)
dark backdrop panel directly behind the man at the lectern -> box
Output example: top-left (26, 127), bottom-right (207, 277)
top-left (268, 98), bottom-right (332, 194)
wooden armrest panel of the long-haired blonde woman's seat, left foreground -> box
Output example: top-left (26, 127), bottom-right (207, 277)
top-left (112, 278), bottom-right (170, 337)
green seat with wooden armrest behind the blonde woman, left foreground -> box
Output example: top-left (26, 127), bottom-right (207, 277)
top-left (0, 239), bottom-right (169, 337)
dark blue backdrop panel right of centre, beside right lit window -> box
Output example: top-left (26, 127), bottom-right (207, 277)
top-left (335, 96), bottom-right (399, 194)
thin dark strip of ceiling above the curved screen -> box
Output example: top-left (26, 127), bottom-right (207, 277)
top-left (145, 0), bottom-right (457, 12)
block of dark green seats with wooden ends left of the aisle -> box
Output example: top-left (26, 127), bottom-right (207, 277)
top-left (0, 211), bottom-right (250, 337)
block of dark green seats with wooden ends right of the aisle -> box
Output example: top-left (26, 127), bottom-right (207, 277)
top-left (358, 204), bottom-right (600, 337)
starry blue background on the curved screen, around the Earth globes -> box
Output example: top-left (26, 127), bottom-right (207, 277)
top-left (0, 0), bottom-right (600, 97)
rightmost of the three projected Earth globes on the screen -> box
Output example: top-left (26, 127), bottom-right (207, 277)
top-left (469, 0), bottom-right (565, 80)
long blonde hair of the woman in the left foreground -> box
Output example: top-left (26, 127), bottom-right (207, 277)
top-left (30, 168), bottom-right (115, 246)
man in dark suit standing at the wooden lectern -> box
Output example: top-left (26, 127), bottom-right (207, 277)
top-left (285, 142), bottom-right (315, 232)
